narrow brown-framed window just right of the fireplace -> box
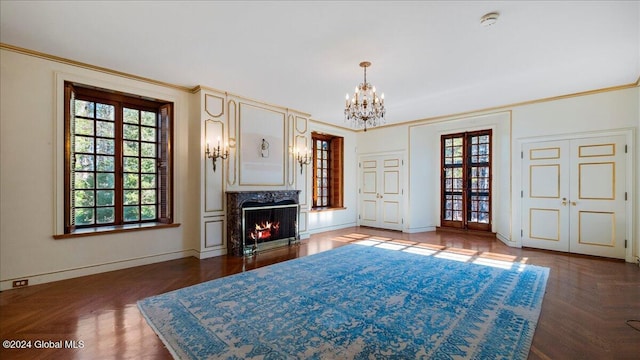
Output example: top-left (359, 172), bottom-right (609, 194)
top-left (311, 132), bottom-right (343, 209)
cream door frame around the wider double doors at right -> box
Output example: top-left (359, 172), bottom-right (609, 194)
top-left (512, 128), bottom-right (640, 263)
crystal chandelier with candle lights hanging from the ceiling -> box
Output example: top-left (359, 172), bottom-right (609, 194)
top-left (344, 61), bottom-right (386, 131)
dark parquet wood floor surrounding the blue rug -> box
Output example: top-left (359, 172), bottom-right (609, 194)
top-left (0, 227), bottom-right (640, 359)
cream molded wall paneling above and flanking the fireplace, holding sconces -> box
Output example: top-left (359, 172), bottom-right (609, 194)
top-left (192, 87), bottom-right (311, 258)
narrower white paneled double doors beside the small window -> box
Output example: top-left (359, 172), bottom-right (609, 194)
top-left (358, 154), bottom-right (404, 230)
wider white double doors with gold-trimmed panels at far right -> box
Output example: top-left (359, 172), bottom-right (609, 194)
top-left (522, 135), bottom-right (627, 259)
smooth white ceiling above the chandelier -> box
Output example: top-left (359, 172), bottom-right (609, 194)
top-left (0, 0), bottom-right (640, 125)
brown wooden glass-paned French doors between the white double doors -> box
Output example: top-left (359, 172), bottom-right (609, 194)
top-left (441, 130), bottom-right (491, 230)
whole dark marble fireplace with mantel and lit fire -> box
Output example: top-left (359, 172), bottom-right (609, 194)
top-left (227, 190), bottom-right (300, 256)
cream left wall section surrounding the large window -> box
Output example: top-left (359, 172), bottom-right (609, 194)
top-left (0, 49), bottom-right (198, 289)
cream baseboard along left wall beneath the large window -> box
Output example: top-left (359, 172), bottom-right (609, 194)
top-left (0, 250), bottom-right (197, 291)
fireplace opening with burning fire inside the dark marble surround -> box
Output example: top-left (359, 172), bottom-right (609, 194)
top-left (242, 201), bottom-right (298, 256)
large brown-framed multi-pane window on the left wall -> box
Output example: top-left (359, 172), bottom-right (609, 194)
top-left (65, 83), bottom-right (172, 233)
